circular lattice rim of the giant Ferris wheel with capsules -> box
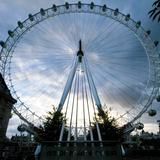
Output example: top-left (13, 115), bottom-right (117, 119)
top-left (0, 2), bottom-right (159, 125)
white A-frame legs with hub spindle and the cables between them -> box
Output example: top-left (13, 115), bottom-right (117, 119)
top-left (57, 40), bottom-right (102, 141)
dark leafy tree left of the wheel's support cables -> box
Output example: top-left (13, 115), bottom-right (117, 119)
top-left (36, 108), bottom-right (68, 141)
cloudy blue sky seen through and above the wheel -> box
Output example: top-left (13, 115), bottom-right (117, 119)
top-left (0, 0), bottom-right (159, 138)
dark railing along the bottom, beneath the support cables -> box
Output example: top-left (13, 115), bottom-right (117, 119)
top-left (35, 141), bottom-right (124, 160)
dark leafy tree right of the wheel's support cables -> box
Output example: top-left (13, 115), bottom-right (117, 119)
top-left (88, 109), bottom-right (122, 141)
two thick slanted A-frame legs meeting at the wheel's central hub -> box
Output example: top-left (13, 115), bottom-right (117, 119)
top-left (57, 40), bottom-right (102, 141)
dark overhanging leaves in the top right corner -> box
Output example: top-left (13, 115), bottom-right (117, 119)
top-left (148, 0), bottom-right (160, 22)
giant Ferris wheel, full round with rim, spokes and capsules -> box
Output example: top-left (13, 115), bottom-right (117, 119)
top-left (0, 2), bottom-right (160, 131)
